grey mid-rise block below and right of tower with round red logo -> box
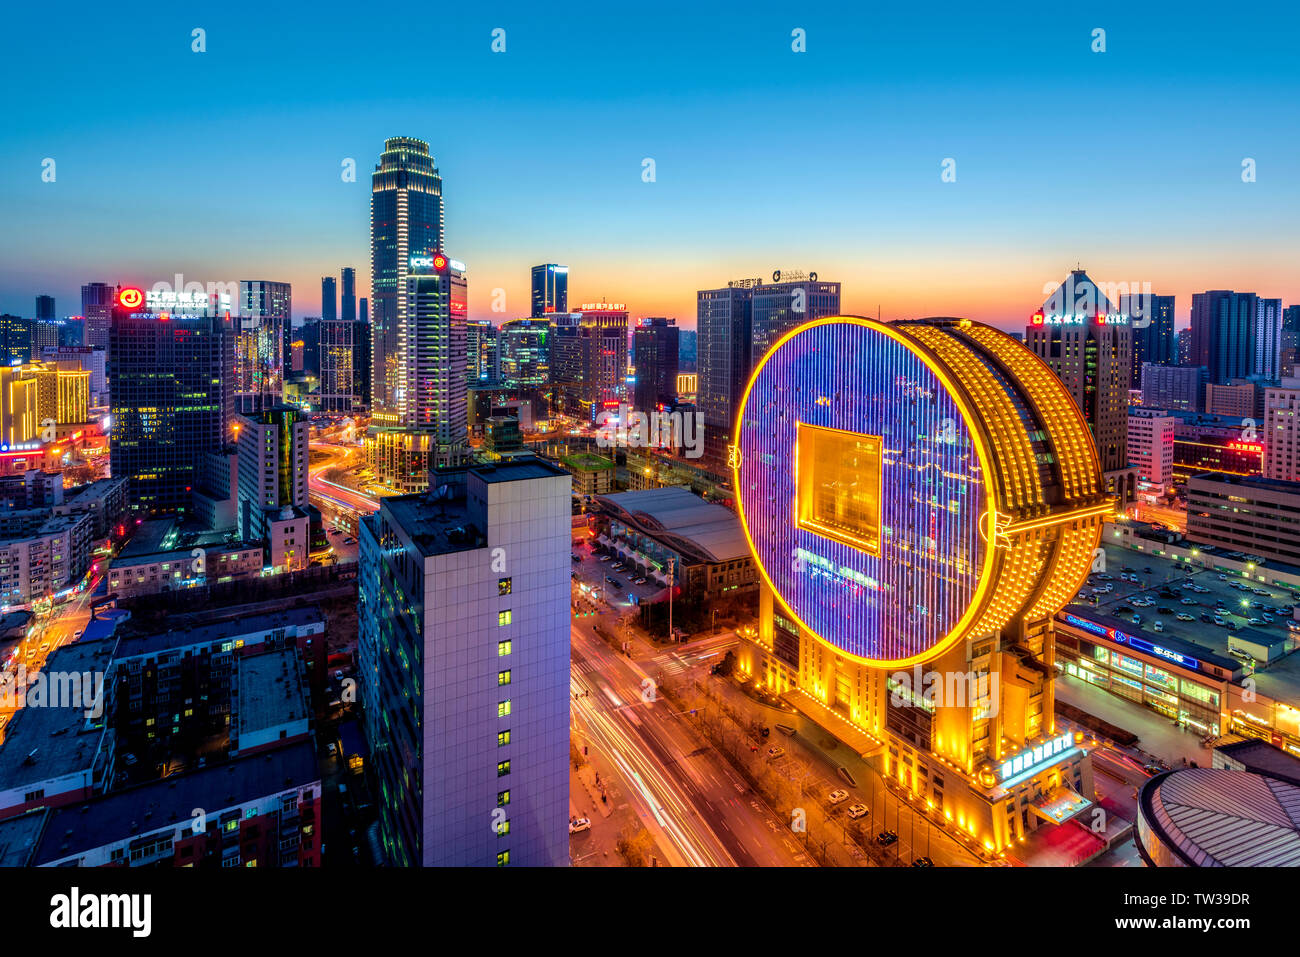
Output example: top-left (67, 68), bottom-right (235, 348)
top-left (235, 404), bottom-right (311, 571)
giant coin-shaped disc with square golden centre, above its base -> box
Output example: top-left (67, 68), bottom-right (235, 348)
top-left (733, 316), bottom-right (1112, 667)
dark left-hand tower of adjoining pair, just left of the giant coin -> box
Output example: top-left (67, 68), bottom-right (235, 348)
top-left (696, 280), bottom-right (761, 476)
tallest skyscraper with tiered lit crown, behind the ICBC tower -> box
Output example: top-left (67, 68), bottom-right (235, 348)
top-left (371, 137), bottom-right (443, 423)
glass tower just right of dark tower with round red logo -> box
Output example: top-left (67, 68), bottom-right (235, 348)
top-left (235, 280), bottom-right (294, 412)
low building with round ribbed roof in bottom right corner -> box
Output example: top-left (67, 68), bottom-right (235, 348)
top-left (1138, 767), bottom-right (1300, 867)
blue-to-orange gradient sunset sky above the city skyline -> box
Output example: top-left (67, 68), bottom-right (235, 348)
top-left (0, 3), bottom-right (1300, 329)
